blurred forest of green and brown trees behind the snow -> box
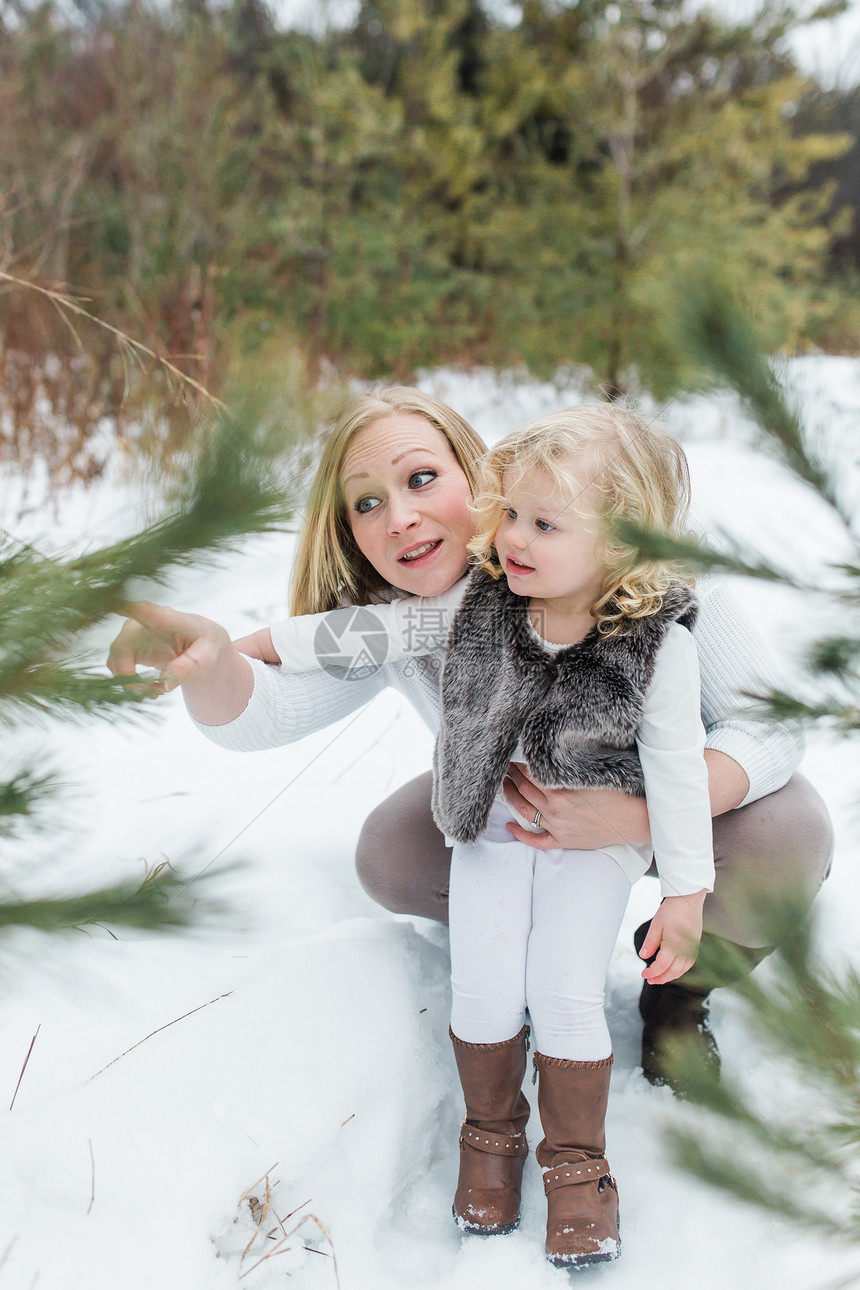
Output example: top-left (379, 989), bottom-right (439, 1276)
top-left (0, 0), bottom-right (860, 479)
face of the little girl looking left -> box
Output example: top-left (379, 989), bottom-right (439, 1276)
top-left (495, 471), bottom-right (605, 613)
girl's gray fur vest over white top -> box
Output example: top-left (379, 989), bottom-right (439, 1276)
top-left (433, 569), bottom-right (696, 842)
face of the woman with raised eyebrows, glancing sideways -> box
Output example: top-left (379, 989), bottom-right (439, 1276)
top-left (340, 412), bottom-right (474, 596)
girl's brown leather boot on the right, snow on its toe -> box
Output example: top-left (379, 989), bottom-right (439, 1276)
top-left (535, 1053), bottom-right (620, 1268)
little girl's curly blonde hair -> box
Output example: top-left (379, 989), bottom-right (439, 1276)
top-left (469, 404), bottom-right (694, 636)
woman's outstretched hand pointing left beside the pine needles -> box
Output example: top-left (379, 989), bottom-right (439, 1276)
top-left (107, 600), bottom-right (254, 725)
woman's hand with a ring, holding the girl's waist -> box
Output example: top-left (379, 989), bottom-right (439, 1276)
top-left (503, 761), bottom-right (649, 851)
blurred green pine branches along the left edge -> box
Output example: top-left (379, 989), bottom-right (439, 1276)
top-left (0, 393), bottom-right (293, 946)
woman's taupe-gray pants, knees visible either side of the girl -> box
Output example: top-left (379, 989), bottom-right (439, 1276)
top-left (356, 771), bottom-right (833, 949)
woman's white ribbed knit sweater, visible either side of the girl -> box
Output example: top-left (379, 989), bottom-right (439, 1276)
top-left (195, 578), bottom-right (803, 805)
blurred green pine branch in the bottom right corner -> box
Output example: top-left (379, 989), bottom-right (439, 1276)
top-left (668, 895), bottom-right (860, 1240)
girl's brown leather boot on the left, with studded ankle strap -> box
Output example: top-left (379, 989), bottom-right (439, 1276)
top-left (449, 1026), bottom-right (529, 1236)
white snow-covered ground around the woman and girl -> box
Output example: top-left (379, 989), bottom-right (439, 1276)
top-left (0, 359), bottom-right (860, 1290)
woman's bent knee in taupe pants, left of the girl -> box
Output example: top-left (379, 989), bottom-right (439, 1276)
top-left (356, 770), bottom-right (451, 922)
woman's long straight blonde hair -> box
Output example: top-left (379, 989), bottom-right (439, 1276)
top-left (290, 386), bottom-right (486, 614)
